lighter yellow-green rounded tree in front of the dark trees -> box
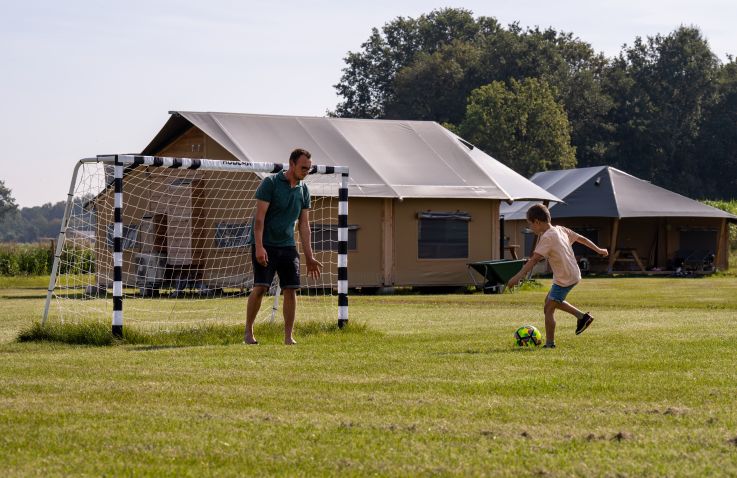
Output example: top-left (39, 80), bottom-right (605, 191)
top-left (459, 78), bottom-right (576, 176)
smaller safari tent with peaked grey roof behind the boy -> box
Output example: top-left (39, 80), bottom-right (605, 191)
top-left (501, 166), bottom-right (737, 273)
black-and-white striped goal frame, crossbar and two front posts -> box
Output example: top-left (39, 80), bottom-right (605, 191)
top-left (97, 154), bottom-right (349, 332)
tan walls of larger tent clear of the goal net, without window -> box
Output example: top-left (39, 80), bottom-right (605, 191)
top-left (193, 127), bottom-right (506, 287)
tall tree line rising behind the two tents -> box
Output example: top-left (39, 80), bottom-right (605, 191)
top-left (328, 8), bottom-right (737, 200)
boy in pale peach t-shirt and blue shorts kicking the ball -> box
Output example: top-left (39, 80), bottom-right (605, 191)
top-left (507, 204), bottom-right (609, 348)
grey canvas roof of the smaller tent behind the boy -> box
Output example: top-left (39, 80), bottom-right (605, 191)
top-left (500, 166), bottom-right (737, 221)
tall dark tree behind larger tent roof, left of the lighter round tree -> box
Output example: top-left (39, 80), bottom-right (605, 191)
top-left (332, 8), bottom-right (612, 172)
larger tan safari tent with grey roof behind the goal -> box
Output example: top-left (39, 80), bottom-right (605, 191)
top-left (90, 111), bottom-right (558, 288)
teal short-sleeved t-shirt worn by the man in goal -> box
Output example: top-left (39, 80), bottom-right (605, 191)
top-left (248, 171), bottom-right (311, 247)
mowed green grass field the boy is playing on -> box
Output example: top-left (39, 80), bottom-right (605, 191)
top-left (0, 277), bottom-right (737, 476)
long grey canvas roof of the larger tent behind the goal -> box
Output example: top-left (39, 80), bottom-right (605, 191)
top-left (143, 111), bottom-right (559, 201)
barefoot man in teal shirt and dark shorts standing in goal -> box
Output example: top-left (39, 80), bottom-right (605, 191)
top-left (244, 148), bottom-right (322, 345)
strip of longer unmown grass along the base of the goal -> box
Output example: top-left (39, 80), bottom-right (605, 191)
top-left (16, 322), bottom-right (380, 350)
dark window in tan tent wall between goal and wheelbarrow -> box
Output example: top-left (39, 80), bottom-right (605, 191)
top-left (417, 211), bottom-right (471, 259)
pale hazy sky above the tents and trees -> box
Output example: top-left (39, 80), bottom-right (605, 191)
top-left (0, 0), bottom-right (737, 207)
